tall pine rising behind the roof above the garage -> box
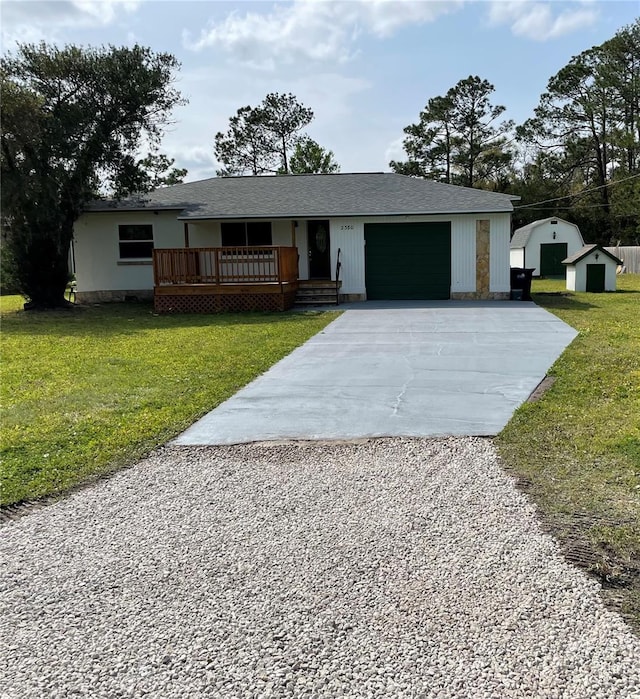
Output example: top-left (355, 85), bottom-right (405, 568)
top-left (390, 75), bottom-right (513, 187)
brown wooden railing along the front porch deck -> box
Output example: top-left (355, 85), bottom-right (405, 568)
top-left (153, 245), bottom-right (298, 286)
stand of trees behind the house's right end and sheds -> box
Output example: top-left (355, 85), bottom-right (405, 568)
top-left (390, 20), bottom-right (640, 245)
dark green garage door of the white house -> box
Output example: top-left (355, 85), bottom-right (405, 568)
top-left (364, 223), bottom-right (451, 300)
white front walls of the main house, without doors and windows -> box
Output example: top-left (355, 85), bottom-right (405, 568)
top-left (75, 212), bottom-right (510, 295)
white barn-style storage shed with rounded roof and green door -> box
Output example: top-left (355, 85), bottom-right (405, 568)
top-left (509, 217), bottom-right (584, 277)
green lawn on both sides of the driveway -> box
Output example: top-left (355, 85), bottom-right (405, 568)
top-left (0, 275), bottom-right (640, 628)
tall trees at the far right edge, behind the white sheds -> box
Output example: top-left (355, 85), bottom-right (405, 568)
top-left (517, 20), bottom-right (640, 243)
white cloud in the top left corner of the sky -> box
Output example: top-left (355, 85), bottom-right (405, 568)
top-left (0, 0), bottom-right (140, 48)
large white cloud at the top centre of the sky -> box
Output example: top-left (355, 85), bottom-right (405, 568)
top-left (183, 0), bottom-right (463, 68)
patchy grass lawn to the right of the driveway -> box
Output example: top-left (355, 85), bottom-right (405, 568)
top-left (497, 275), bottom-right (640, 629)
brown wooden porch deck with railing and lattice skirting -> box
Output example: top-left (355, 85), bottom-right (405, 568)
top-left (153, 246), bottom-right (298, 313)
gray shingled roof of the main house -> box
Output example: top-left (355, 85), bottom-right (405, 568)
top-left (86, 172), bottom-right (519, 220)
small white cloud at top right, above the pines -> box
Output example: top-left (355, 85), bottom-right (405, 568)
top-left (489, 0), bottom-right (599, 41)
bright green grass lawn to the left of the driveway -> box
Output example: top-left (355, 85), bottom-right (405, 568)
top-left (0, 296), bottom-right (336, 506)
